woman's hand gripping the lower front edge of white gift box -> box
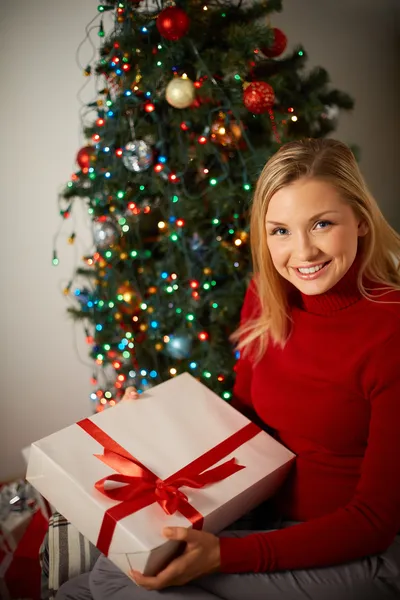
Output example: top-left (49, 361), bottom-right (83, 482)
top-left (131, 527), bottom-right (221, 590)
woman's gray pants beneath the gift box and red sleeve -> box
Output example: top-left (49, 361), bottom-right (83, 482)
top-left (56, 522), bottom-right (400, 600)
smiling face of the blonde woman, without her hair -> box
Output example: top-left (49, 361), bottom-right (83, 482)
top-left (265, 179), bottom-right (367, 295)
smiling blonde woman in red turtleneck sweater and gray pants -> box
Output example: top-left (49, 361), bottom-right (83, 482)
top-left (57, 139), bottom-right (400, 600)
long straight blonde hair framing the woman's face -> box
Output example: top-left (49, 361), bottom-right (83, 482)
top-left (232, 139), bottom-right (400, 361)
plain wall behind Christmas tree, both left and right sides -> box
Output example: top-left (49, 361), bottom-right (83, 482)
top-left (0, 0), bottom-right (400, 480)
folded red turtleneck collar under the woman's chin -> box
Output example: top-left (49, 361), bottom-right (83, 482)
top-left (300, 257), bottom-right (362, 315)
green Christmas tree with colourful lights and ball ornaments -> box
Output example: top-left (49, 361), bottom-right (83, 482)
top-left (53, 0), bottom-right (353, 410)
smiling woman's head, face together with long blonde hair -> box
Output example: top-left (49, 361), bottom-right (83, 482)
top-left (232, 139), bottom-right (400, 359)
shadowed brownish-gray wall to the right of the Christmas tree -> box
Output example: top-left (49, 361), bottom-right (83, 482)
top-left (273, 0), bottom-right (400, 231)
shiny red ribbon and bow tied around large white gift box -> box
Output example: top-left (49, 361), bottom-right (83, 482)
top-left (77, 419), bottom-right (261, 556)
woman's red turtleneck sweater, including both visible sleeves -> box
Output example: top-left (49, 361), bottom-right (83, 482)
top-left (220, 265), bottom-right (400, 573)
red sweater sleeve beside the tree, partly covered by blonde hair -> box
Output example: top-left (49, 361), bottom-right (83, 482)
top-left (231, 281), bottom-right (256, 416)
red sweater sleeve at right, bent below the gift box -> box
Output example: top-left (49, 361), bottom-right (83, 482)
top-left (220, 328), bottom-right (400, 573)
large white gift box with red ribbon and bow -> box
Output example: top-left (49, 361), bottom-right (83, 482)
top-left (27, 373), bottom-right (294, 575)
